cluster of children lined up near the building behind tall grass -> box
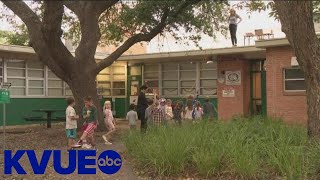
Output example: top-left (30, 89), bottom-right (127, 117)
top-left (127, 92), bottom-right (216, 128)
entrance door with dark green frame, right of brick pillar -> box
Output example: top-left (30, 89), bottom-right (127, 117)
top-left (250, 60), bottom-right (267, 115)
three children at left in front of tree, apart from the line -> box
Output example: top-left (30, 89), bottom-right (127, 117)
top-left (66, 97), bottom-right (115, 150)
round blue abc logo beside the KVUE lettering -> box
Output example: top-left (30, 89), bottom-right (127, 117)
top-left (97, 150), bottom-right (122, 174)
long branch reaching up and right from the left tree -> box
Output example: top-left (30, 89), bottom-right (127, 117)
top-left (93, 0), bottom-right (201, 74)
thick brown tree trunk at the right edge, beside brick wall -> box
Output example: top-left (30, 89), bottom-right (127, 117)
top-left (274, 1), bottom-right (320, 137)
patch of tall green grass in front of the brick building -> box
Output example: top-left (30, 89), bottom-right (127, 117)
top-left (124, 117), bottom-right (320, 179)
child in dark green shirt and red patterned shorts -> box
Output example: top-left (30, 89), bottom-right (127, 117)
top-left (77, 97), bottom-right (98, 149)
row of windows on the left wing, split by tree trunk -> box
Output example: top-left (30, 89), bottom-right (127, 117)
top-left (0, 59), bottom-right (127, 97)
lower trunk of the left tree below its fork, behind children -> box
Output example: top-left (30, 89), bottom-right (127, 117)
top-left (68, 72), bottom-right (105, 130)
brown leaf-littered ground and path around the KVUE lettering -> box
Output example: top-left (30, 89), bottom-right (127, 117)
top-left (0, 122), bottom-right (144, 180)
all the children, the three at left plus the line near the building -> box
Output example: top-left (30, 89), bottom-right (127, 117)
top-left (66, 95), bottom-right (216, 150)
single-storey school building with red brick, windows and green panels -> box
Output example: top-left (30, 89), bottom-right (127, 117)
top-left (0, 38), bottom-right (307, 125)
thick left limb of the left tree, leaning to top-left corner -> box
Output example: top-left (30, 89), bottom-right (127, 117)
top-left (2, 0), bottom-right (68, 81)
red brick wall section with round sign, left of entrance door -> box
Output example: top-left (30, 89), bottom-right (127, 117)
top-left (218, 58), bottom-right (250, 120)
